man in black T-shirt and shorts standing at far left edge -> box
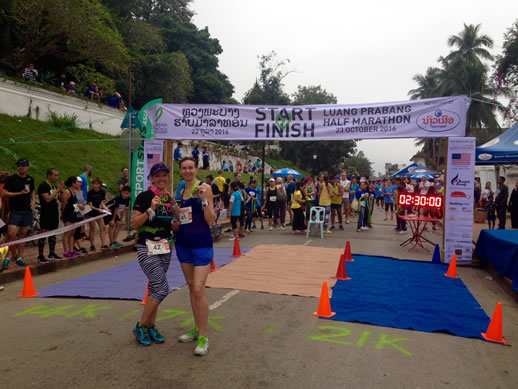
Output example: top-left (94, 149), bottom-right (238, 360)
top-left (2, 158), bottom-right (36, 269)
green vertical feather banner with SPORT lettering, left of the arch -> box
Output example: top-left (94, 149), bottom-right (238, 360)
top-left (130, 99), bottom-right (163, 204)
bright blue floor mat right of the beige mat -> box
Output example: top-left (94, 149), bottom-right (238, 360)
top-left (331, 255), bottom-right (490, 339)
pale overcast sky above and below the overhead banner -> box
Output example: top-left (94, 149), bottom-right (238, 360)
top-left (191, 0), bottom-right (518, 173)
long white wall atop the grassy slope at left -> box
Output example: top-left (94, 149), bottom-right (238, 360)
top-left (0, 78), bottom-right (124, 135)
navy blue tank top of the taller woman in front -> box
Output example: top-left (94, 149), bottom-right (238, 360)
top-left (176, 197), bottom-right (212, 249)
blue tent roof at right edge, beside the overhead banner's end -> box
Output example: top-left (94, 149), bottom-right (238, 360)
top-left (475, 124), bottom-right (518, 165)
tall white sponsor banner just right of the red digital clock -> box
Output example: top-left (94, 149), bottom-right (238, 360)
top-left (444, 138), bottom-right (475, 264)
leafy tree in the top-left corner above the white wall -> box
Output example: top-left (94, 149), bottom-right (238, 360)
top-left (0, 0), bottom-right (128, 76)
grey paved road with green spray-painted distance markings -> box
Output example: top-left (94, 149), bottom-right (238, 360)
top-left (0, 221), bottom-right (518, 388)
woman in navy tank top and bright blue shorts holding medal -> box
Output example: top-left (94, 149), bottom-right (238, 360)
top-left (175, 157), bottom-right (216, 355)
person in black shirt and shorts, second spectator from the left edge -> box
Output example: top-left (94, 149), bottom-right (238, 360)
top-left (38, 169), bottom-right (64, 263)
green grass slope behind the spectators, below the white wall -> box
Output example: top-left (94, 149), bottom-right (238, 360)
top-left (0, 114), bottom-right (309, 193)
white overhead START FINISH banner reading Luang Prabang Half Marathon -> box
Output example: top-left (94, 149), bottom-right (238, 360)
top-left (147, 96), bottom-right (471, 141)
